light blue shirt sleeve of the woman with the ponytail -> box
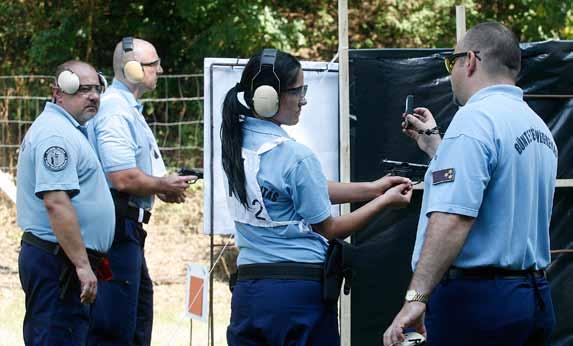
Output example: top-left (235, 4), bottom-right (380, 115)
top-left (285, 155), bottom-right (330, 224)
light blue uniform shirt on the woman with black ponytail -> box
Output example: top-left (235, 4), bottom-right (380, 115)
top-left (235, 117), bottom-right (330, 265)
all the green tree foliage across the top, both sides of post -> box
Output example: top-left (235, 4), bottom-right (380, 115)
top-left (0, 0), bottom-right (573, 74)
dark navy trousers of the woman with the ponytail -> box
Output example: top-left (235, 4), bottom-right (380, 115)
top-left (227, 279), bottom-right (340, 346)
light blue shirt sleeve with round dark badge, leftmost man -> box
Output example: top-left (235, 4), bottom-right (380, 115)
top-left (34, 136), bottom-right (80, 199)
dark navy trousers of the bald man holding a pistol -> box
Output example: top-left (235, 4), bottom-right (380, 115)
top-left (88, 218), bottom-right (153, 346)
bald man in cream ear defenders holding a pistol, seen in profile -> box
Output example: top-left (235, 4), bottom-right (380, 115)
top-left (88, 37), bottom-right (196, 345)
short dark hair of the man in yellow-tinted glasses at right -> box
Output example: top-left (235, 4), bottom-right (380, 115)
top-left (463, 22), bottom-right (521, 80)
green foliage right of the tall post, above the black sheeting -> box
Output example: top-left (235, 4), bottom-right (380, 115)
top-left (342, 0), bottom-right (573, 48)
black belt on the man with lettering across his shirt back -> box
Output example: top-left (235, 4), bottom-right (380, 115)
top-left (444, 267), bottom-right (545, 280)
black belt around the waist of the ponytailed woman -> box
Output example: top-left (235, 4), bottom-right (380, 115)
top-left (237, 262), bottom-right (323, 281)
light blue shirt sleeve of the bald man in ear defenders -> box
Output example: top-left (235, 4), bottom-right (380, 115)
top-left (95, 114), bottom-right (139, 173)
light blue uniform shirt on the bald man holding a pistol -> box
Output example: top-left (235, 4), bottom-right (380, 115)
top-left (88, 79), bottom-right (158, 209)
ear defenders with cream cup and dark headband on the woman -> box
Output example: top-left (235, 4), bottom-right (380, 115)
top-left (251, 48), bottom-right (281, 118)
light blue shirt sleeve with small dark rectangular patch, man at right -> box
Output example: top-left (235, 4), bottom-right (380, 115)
top-left (425, 134), bottom-right (496, 217)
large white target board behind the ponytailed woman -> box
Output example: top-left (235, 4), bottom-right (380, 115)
top-left (203, 58), bottom-right (340, 234)
